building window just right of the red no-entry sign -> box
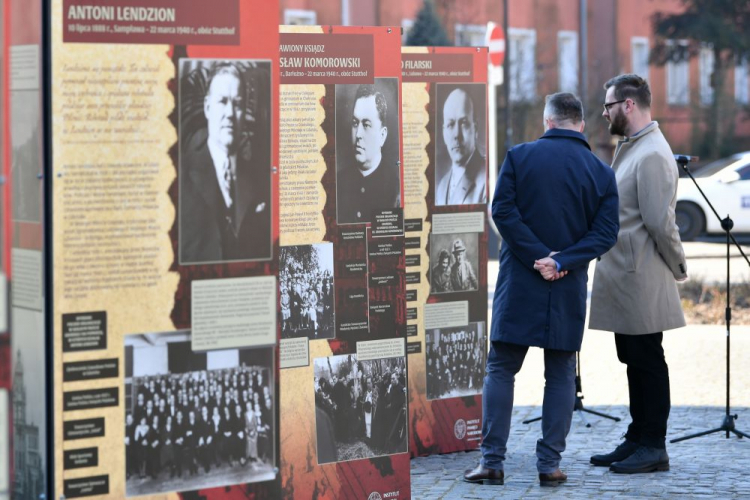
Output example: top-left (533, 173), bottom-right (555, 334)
top-left (508, 28), bottom-right (536, 101)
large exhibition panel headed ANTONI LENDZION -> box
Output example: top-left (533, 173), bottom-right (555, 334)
top-left (46, 0), bottom-right (280, 498)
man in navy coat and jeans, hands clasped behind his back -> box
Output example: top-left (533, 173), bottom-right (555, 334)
top-left (464, 93), bottom-right (619, 486)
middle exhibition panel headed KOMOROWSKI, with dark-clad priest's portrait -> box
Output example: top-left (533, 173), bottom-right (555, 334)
top-left (279, 26), bottom-right (410, 498)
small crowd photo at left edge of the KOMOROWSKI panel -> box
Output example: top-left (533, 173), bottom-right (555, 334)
top-left (279, 243), bottom-right (336, 340)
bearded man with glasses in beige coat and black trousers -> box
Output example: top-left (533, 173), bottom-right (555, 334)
top-left (589, 74), bottom-right (687, 473)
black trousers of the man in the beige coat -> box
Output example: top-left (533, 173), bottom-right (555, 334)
top-left (615, 332), bottom-right (671, 448)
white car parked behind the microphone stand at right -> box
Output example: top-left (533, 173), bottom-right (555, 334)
top-left (676, 151), bottom-right (750, 241)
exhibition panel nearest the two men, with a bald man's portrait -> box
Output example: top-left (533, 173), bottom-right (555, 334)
top-left (402, 47), bottom-right (489, 456)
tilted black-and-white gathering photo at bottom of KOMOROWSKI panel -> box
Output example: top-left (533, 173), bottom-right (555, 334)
top-left (313, 354), bottom-right (408, 464)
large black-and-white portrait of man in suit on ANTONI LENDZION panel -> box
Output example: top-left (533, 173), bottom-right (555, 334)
top-left (178, 59), bottom-right (272, 265)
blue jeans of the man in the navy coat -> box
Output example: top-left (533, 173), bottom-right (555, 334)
top-left (482, 341), bottom-right (576, 473)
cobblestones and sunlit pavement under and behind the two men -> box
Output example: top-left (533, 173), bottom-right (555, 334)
top-left (412, 326), bottom-right (750, 499)
